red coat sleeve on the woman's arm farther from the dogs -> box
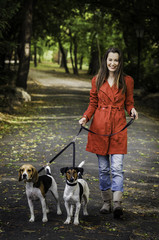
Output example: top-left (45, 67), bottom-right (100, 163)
top-left (125, 76), bottom-right (134, 115)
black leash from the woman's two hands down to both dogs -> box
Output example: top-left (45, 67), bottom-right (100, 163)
top-left (38, 116), bottom-right (135, 173)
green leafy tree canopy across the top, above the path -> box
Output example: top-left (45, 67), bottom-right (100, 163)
top-left (0, 0), bottom-right (159, 91)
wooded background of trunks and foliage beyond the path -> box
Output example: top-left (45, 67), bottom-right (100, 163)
top-left (0, 0), bottom-right (159, 93)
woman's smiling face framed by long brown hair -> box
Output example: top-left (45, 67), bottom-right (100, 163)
top-left (107, 52), bottom-right (119, 72)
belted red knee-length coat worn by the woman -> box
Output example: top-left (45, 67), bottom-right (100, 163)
top-left (84, 76), bottom-right (134, 155)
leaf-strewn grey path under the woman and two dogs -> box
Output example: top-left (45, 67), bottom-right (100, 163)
top-left (0, 68), bottom-right (159, 240)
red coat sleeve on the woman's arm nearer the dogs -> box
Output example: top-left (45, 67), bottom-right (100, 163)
top-left (83, 77), bottom-right (98, 121)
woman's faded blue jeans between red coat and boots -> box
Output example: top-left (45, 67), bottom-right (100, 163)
top-left (97, 154), bottom-right (124, 192)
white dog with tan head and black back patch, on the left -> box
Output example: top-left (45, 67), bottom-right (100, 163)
top-left (19, 164), bottom-right (62, 222)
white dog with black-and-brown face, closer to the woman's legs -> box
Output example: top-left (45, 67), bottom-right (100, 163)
top-left (61, 161), bottom-right (89, 225)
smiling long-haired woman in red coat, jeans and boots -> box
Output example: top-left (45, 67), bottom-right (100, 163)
top-left (79, 48), bottom-right (138, 218)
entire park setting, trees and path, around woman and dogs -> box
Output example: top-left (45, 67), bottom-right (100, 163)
top-left (0, 0), bottom-right (159, 240)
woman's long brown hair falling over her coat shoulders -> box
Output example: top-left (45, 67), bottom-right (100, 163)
top-left (96, 47), bottom-right (126, 93)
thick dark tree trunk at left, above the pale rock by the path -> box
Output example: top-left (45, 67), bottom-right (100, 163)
top-left (16, 0), bottom-right (33, 89)
